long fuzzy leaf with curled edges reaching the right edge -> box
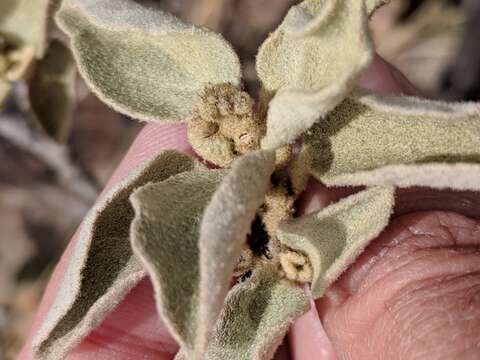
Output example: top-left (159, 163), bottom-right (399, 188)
top-left (303, 93), bottom-right (480, 190)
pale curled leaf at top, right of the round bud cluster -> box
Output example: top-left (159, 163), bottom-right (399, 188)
top-left (257, 0), bottom-right (382, 149)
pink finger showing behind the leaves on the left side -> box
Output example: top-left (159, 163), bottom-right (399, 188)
top-left (19, 125), bottom-right (193, 360)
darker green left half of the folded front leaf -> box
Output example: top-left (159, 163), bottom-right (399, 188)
top-left (131, 171), bottom-right (225, 353)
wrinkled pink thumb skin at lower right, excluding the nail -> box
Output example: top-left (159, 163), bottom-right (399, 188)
top-left (317, 212), bottom-right (480, 360)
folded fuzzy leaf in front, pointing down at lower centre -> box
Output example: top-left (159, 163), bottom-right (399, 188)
top-left (132, 152), bottom-right (275, 356)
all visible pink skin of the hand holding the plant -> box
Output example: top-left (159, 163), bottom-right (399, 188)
top-left (19, 57), bottom-right (480, 360)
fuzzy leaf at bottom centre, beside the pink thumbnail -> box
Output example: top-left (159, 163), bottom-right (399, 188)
top-left (205, 268), bottom-right (309, 360)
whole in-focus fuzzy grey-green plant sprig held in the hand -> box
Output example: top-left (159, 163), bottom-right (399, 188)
top-left (34, 0), bottom-right (480, 360)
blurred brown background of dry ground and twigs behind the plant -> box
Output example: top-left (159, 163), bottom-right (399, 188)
top-left (0, 0), bottom-right (480, 360)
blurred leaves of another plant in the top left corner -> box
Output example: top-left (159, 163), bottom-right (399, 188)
top-left (0, 0), bottom-right (76, 141)
